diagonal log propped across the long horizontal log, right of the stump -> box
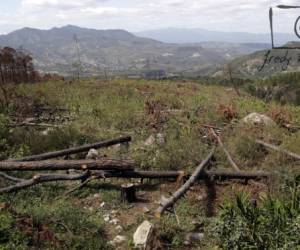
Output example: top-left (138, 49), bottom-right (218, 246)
top-left (155, 147), bottom-right (215, 218)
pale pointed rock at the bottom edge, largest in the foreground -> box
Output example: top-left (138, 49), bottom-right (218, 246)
top-left (133, 220), bottom-right (162, 250)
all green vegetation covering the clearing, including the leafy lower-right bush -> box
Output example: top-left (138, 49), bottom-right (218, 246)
top-left (0, 79), bottom-right (300, 249)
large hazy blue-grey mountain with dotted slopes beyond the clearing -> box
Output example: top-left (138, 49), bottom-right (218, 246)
top-left (0, 25), bottom-right (268, 75)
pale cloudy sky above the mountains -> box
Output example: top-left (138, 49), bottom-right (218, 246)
top-left (0, 0), bottom-right (300, 34)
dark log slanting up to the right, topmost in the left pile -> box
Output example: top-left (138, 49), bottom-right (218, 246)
top-left (11, 136), bottom-right (131, 161)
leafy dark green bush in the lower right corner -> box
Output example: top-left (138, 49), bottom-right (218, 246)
top-left (215, 181), bottom-right (300, 250)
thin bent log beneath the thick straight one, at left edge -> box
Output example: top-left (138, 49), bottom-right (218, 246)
top-left (0, 171), bottom-right (90, 194)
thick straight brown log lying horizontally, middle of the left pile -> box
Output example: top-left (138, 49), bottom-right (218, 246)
top-left (0, 159), bottom-right (134, 171)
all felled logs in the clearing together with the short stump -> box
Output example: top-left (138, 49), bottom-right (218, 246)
top-left (0, 133), bottom-right (300, 218)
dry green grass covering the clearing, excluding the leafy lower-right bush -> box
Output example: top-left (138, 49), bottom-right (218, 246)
top-left (0, 79), bottom-right (300, 249)
